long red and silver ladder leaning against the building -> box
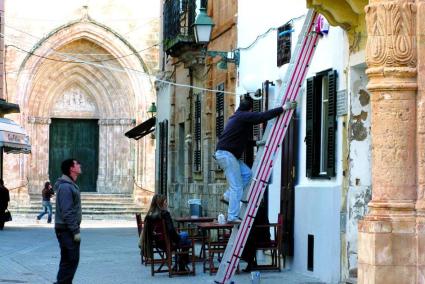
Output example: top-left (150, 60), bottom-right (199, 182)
top-left (214, 10), bottom-right (320, 284)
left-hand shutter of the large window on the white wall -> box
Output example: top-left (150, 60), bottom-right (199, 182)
top-left (305, 77), bottom-right (314, 178)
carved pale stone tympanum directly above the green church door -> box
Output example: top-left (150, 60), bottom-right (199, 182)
top-left (52, 88), bottom-right (97, 115)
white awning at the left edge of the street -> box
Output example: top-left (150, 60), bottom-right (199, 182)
top-left (0, 118), bottom-right (31, 154)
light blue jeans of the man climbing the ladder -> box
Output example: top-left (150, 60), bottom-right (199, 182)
top-left (215, 150), bottom-right (252, 221)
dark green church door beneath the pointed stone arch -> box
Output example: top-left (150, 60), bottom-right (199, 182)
top-left (49, 119), bottom-right (99, 192)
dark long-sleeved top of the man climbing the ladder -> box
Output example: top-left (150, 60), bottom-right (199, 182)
top-left (217, 107), bottom-right (283, 159)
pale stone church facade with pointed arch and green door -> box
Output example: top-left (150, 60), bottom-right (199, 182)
top-left (4, 0), bottom-right (159, 202)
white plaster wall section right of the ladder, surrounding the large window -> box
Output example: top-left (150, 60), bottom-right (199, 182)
top-left (293, 28), bottom-right (348, 283)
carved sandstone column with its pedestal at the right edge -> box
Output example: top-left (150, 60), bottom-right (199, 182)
top-left (358, 0), bottom-right (417, 283)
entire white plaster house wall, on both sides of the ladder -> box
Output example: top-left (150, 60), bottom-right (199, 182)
top-left (237, 0), bottom-right (348, 283)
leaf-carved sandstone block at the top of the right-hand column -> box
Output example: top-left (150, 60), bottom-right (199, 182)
top-left (366, 1), bottom-right (417, 67)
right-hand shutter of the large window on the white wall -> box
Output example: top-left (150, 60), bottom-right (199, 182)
top-left (327, 70), bottom-right (337, 177)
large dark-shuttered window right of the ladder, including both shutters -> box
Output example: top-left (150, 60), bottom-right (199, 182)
top-left (305, 70), bottom-right (337, 178)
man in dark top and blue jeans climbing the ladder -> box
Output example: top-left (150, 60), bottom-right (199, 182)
top-left (215, 97), bottom-right (297, 223)
